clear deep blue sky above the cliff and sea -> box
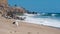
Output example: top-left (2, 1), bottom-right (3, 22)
top-left (8, 0), bottom-right (60, 13)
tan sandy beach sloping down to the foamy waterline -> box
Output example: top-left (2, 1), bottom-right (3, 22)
top-left (0, 16), bottom-right (60, 34)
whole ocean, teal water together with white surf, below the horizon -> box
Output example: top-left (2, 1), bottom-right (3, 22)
top-left (24, 13), bottom-right (60, 28)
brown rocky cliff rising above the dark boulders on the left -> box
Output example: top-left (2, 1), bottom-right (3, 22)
top-left (0, 0), bottom-right (25, 17)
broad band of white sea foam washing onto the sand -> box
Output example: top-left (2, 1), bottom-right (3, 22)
top-left (24, 15), bottom-right (60, 28)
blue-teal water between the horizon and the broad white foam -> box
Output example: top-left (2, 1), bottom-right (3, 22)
top-left (34, 13), bottom-right (60, 21)
